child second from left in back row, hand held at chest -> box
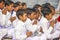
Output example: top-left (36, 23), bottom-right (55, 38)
top-left (3, 1), bottom-right (14, 37)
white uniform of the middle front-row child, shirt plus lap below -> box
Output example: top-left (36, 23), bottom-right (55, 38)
top-left (25, 18), bottom-right (46, 40)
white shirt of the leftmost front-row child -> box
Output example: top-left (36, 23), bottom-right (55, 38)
top-left (15, 20), bottom-right (27, 40)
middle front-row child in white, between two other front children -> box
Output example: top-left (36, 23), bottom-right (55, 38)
top-left (25, 8), bottom-right (45, 40)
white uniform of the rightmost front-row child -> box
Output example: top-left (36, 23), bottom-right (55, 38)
top-left (39, 16), bottom-right (53, 39)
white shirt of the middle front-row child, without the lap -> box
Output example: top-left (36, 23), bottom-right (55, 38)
top-left (25, 18), bottom-right (38, 33)
